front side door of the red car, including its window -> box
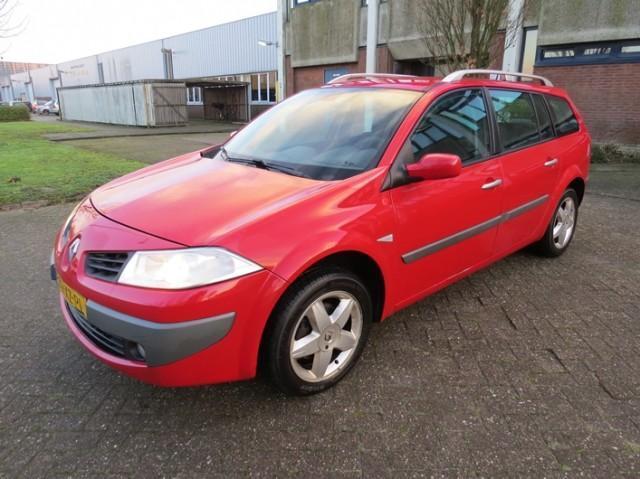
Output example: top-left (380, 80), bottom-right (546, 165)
top-left (390, 88), bottom-right (502, 305)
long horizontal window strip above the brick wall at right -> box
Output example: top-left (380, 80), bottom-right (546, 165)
top-left (536, 40), bottom-right (640, 67)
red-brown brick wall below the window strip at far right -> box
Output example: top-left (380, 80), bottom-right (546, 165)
top-left (535, 63), bottom-right (640, 145)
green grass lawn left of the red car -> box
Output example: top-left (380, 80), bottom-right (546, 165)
top-left (0, 121), bottom-right (145, 206)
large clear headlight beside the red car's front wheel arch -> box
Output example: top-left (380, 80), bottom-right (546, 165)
top-left (118, 248), bottom-right (262, 289)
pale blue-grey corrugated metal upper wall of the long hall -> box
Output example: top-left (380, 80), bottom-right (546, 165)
top-left (3, 12), bottom-right (278, 106)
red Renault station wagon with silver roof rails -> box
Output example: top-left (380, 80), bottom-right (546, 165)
top-left (51, 70), bottom-right (590, 394)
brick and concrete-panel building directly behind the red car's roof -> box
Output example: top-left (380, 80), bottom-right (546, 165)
top-left (279, 0), bottom-right (640, 145)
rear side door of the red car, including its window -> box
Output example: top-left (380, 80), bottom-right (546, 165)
top-left (489, 88), bottom-right (559, 255)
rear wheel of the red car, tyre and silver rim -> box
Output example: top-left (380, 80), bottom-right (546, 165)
top-left (536, 188), bottom-right (578, 258)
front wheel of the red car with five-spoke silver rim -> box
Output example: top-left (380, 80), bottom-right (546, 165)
top-left (265, 268), bottom-right (374, 395)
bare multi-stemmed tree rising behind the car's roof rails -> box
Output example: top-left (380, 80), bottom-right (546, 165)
top-left (413, 0), bottom-right (524, 70)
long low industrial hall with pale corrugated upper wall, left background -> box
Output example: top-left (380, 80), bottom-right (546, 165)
top-left (0, 12), bottom-right (278, 124)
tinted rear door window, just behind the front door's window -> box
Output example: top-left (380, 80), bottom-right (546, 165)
top-left (490, 90), bottom-right (540, 150)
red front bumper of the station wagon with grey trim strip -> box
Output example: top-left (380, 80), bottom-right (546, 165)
top-left (52, 201), bottom-right (286, 386)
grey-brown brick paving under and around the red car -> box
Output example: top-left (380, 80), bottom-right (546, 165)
top-left (0, 187), bottom-right (640, 478)
